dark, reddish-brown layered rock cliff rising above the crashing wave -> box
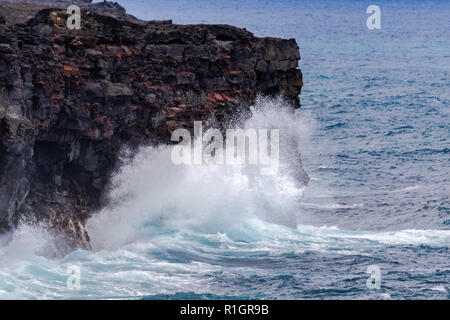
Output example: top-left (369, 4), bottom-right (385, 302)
top-left (0, 4), bottom-right (302, 254)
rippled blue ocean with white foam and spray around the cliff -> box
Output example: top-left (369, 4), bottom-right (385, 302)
top-left (0, 0), bottom-right (450, 299)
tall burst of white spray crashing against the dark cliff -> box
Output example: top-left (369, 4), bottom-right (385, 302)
top-left (87, 98), bottom-right (308, 249)
